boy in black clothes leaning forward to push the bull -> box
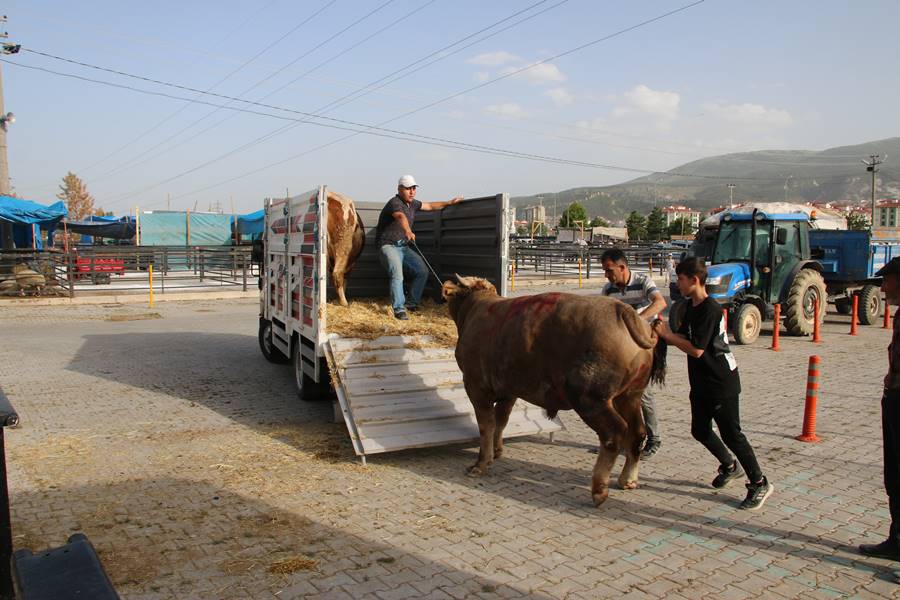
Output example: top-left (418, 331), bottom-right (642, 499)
top-left (655, 257), bottom-right (775, 510)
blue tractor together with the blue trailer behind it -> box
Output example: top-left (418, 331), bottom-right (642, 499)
top-left (671, 209), bottom-right (900, 344)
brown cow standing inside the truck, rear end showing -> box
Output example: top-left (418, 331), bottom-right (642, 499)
top-left (328, 190), bottom-right (366, 306)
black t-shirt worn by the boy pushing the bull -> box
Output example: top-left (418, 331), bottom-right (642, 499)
top-left (678, 297), bottom-right (741, 398)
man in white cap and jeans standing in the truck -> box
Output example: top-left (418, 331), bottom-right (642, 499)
top-left (375, 175), bottom-right (462, 321)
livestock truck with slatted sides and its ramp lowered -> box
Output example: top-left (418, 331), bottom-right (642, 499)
top-left (259, 186), bottom-right (562, 462)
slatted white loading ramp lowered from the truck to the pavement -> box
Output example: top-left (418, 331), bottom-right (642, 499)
top-left (325, 336), bottom-right (563, 463)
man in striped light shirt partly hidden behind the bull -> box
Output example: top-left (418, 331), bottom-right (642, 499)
top-left (600, 248), bottom-right (666, 460)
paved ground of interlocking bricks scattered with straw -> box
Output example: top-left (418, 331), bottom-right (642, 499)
top-left (0, 288), bottom-right (900, 600)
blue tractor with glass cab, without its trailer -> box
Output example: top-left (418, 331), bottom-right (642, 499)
top-left (671, 209), bottom-right (826, 344)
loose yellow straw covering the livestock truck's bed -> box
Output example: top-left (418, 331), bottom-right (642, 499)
top-left (328, 298), bottom-right (456, 348)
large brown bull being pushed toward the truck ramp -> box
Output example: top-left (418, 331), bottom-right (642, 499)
top-left (442, 275), bottom-right (666, 506)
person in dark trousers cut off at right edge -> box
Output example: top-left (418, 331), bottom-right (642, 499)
top-left (859, 257), bottom-right (900, 564)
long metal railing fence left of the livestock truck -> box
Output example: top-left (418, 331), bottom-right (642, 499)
top-left (0, 246), bottom-right (259, 297)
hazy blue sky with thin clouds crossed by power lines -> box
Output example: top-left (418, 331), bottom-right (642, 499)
top-left (0, 0), bottom-right (900, 214)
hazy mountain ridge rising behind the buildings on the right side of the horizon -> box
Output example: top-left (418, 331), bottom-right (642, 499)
top-left (510, 137), bottom-right (900, 224)
